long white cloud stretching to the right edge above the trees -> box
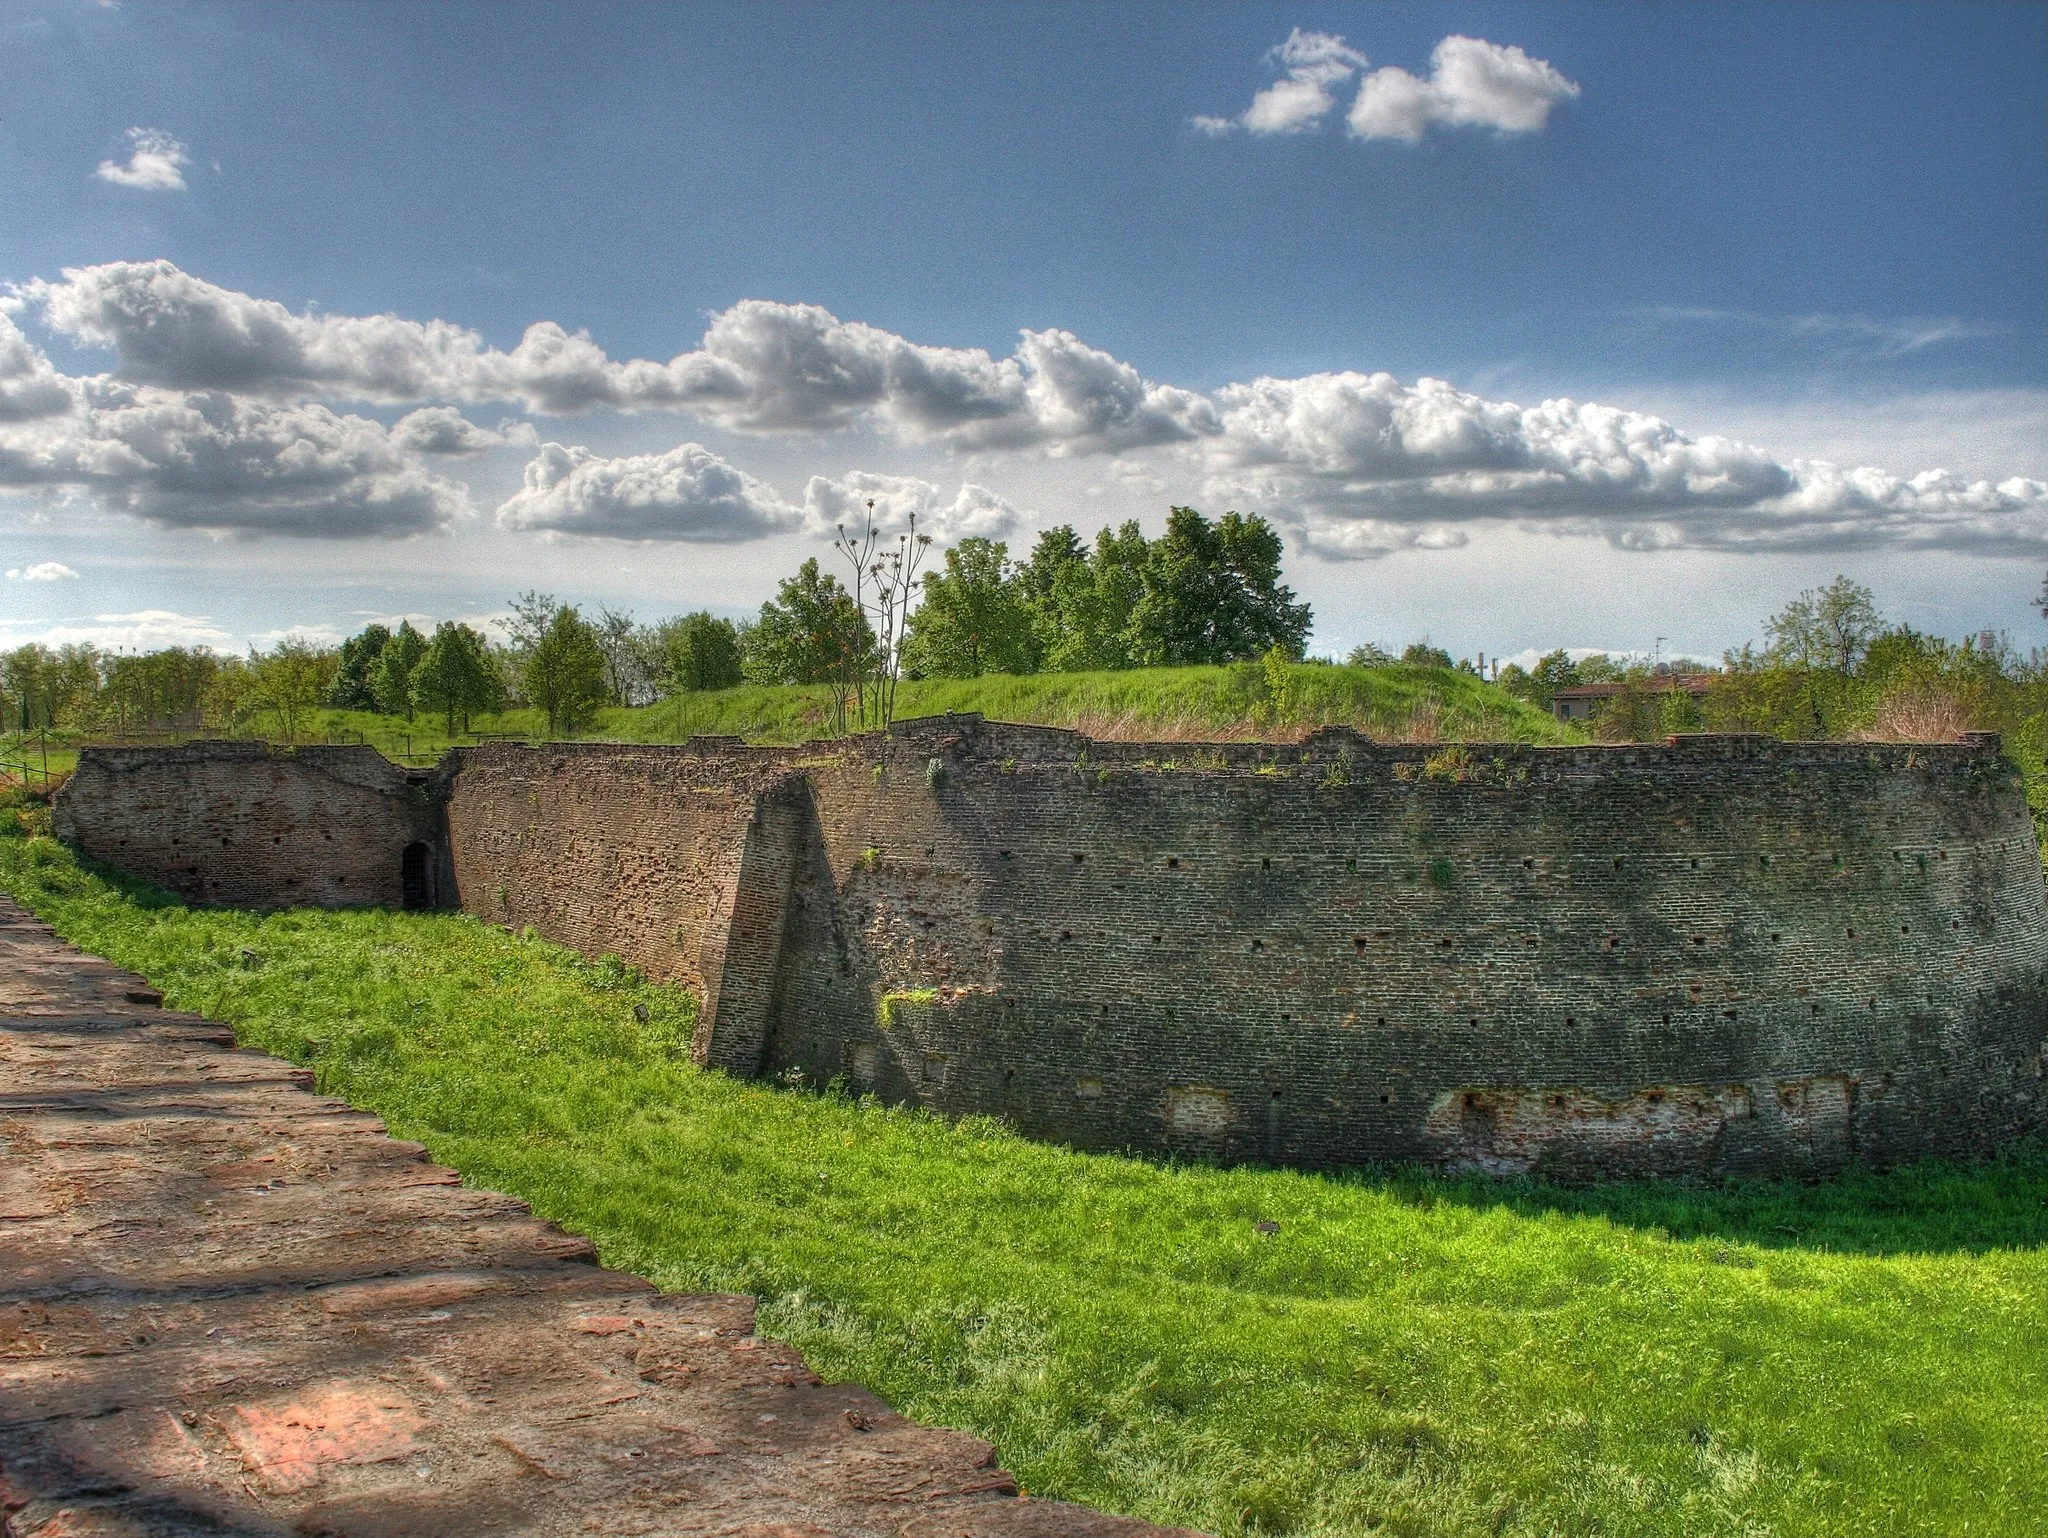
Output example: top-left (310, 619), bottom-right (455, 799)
top-left (1206, 373), bottom-right (2048, 559)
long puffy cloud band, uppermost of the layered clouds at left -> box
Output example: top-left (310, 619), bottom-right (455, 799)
top-left (16, 260), bottom-right (1212, 453)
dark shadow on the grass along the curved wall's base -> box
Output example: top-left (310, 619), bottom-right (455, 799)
top-left (1358, 1141), bottom-right (2048, 1255)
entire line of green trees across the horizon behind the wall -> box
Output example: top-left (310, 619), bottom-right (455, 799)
top-left (0, 536), bottom-right (2048, 784)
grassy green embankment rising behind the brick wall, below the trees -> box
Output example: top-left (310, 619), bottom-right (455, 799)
top-left (0, 664), bottom-right (1581, 774)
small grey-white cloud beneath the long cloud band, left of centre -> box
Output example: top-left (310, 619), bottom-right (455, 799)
top-left (498, 442), bottom-right (801, 545)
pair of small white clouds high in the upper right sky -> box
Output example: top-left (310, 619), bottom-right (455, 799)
top-left (1188, 27), bottom-right (1579, 143)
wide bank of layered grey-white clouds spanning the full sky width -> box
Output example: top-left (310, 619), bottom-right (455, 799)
top-left (0, 260), bottom-right (2048, 559)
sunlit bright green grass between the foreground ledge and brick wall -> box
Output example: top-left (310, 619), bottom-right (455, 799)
top-left (0, 811), bottom-right (2048, 1538)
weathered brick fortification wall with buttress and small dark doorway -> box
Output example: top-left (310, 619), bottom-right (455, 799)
top-left (57, 715), bottom-right (2048, 1180)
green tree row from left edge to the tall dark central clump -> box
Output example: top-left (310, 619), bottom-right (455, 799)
top-left (0, 508), bottom-right (1311, 741)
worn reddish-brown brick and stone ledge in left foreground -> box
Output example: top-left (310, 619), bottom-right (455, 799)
top-left (0, 897), bottom-right (1196, 1538)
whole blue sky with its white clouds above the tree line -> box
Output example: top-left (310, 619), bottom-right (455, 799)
top-left (0, 0), bottom-right (2048, 653)
